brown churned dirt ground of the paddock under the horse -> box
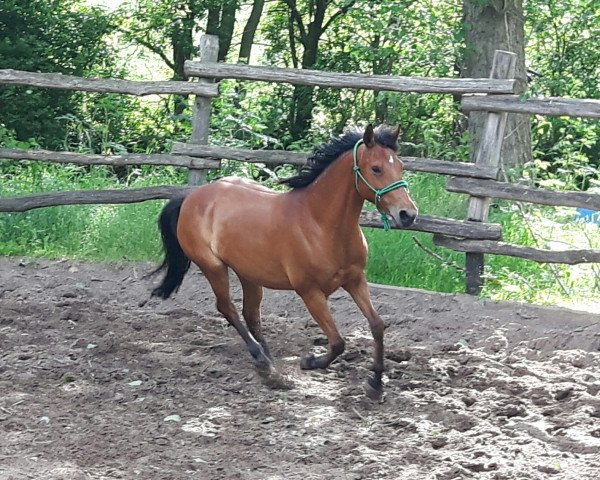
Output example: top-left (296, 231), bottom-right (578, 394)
top-left (0, 258), bottom-right (600, 480)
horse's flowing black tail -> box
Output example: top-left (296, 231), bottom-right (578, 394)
top-left (150, 197), bottom-right (190, 299)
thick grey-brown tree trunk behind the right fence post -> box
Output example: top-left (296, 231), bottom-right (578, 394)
top-left (462, 0), bottom-right (531, 167)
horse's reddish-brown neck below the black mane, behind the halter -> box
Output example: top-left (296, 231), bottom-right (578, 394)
top-left (305, 152), bottom-right (364, 233)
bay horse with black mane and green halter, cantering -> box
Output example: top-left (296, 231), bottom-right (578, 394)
top-left (152, 125), bottom-right (417, 398)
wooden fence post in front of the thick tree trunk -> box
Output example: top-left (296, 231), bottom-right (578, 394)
top-left (465, 50), bottom-right (517, 295)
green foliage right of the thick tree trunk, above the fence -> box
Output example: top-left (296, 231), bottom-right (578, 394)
top-left (526, 0), bottom-right (600, 183)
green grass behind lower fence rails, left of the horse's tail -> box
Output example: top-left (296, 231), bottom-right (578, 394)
top-left (0, 162), bottom-right (184, 260)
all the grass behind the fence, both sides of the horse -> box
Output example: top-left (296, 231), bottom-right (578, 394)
top-left (0, 163), bottom-right (600, 308)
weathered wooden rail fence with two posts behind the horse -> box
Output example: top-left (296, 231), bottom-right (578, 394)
top-left (0, 35), bottom-right (600, 293)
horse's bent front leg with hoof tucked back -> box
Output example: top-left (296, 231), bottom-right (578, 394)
top-left (300, 289), bottom-right (346, 370)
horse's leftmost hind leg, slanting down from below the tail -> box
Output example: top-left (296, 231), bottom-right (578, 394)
top-left (201, 263), bottom-right (271, 369)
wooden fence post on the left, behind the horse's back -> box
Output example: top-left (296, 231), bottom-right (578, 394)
top-left (188, 35), bottom-right (219, 185)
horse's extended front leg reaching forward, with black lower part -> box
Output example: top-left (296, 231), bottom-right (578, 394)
top-left (343, 274), bottom-right (385, 400)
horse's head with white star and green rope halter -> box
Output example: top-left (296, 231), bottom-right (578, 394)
top-left (354, 125), bottom-right (418, 228)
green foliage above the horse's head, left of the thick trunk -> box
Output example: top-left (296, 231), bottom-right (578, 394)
top-left (263, 0), bottom-right (466, 150)
